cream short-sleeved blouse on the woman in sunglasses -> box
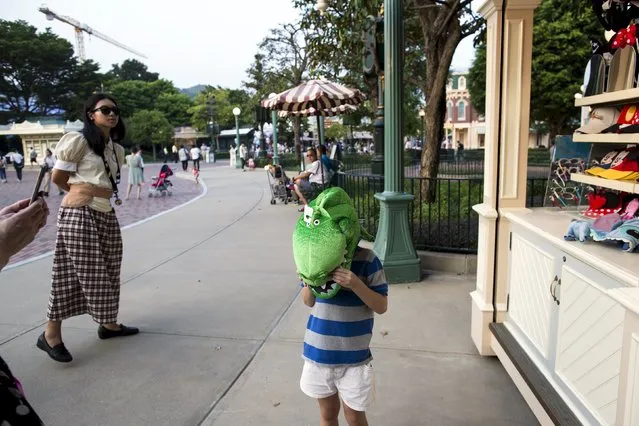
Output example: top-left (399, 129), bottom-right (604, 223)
top-left (54, 132), bottom-right (124, 213)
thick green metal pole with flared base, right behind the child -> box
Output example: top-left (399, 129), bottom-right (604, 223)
top-left (373, 0), bottom-right (421, 283)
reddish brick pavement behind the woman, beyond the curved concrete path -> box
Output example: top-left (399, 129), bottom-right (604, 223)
top-left (0, 161), bottom-right (220, 265)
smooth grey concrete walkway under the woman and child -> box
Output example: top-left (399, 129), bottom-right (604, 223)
top-left (0, 167), bottom-right (536, 426)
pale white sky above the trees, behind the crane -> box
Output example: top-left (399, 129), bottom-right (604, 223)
top-left (0, 0), bottom-right (473, 88)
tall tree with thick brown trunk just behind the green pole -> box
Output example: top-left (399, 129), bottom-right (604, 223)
top-left (294, 0), bottom-right (484, 200)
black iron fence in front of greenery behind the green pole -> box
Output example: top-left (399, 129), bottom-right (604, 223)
top-left (338, 173), bottom-right (547, 253)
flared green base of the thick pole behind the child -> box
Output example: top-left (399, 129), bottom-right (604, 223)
top-left (373, 192), bottom-right (421, 284)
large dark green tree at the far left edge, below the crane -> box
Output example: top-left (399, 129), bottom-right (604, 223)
top-left (0, 20), bottom-right (99, 121)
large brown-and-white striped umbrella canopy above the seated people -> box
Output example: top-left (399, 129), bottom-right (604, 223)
top-left (262, 80), bottom-right (366, 111)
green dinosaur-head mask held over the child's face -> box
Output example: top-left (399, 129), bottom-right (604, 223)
top-left (293, 187), bottom-right (361, 299)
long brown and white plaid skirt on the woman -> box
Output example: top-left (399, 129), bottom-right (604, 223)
top-left (47, 206), bottom-right (122, 324)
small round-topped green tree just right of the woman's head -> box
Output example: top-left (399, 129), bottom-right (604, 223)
top-left (127, 110), bottom-right (173, 160)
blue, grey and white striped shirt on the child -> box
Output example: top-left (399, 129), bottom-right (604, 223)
top-left (303, 247), bottom-right (388, 367)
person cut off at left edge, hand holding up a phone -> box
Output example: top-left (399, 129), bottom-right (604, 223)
top-left (0, 197), bottom-right (49, 426)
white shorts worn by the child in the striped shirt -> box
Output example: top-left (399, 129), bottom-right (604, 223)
top-left (300, 361), bottom-right (375, 411)
